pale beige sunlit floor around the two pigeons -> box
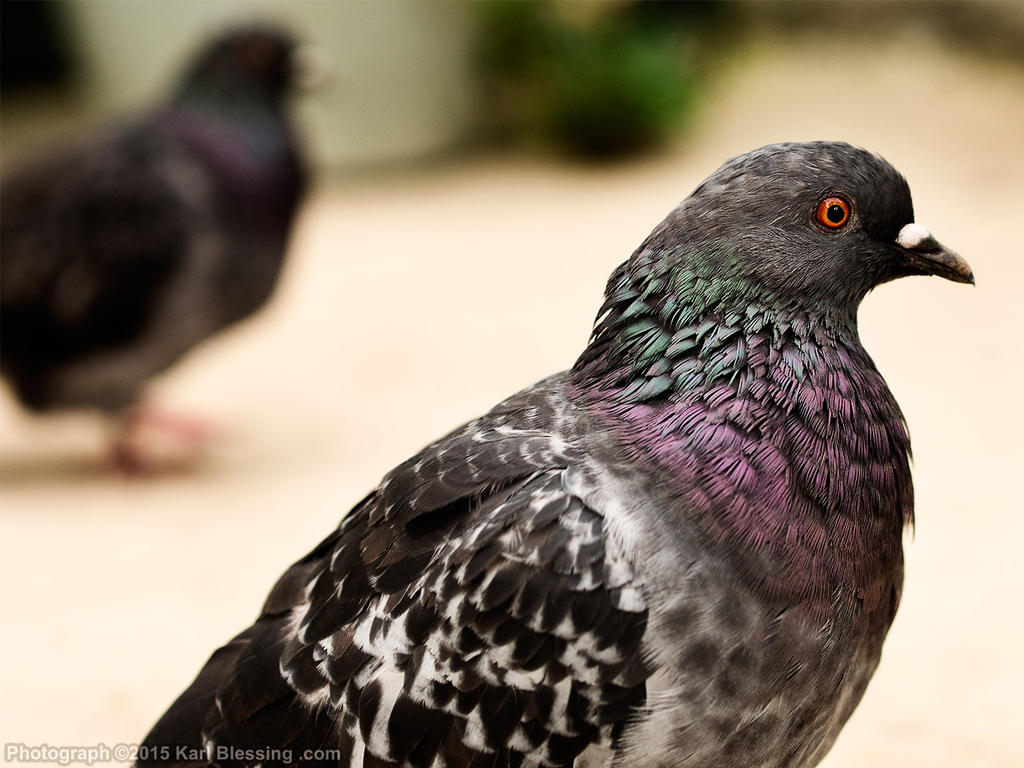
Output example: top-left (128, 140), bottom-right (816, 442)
top-left (0, 40), bottom-right (1024, 768)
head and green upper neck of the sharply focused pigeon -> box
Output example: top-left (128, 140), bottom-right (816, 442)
top-left (573, 141), bottom-right (974, 402)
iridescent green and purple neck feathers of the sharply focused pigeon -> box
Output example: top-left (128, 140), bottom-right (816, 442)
top-left (570, 279), bottom-right (913, 610)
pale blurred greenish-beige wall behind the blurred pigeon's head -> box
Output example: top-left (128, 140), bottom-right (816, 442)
top-left (63, 0), bottom-right (476, 166)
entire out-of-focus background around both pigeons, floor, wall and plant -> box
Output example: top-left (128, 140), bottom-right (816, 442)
top-left (0, 0), bottom-right (1024, 768)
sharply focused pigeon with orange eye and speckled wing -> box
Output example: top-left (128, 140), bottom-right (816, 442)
top-left (139, 141), bottom-right (974, 768)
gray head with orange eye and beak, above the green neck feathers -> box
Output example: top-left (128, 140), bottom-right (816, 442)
top-left (634, 141), bottom-right (974, 309)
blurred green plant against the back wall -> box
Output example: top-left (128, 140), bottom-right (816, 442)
top-left (477, 0), bottom-right (729, 159)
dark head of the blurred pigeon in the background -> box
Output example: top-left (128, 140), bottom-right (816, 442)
top-left (181, 26), bottom-right (303, 101)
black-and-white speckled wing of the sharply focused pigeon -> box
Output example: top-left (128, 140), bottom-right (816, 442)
top-left (138, 385), bottom-right (649, 767)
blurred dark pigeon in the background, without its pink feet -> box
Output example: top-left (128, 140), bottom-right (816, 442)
top-left (0, 27), bottom-right (306, 468)
